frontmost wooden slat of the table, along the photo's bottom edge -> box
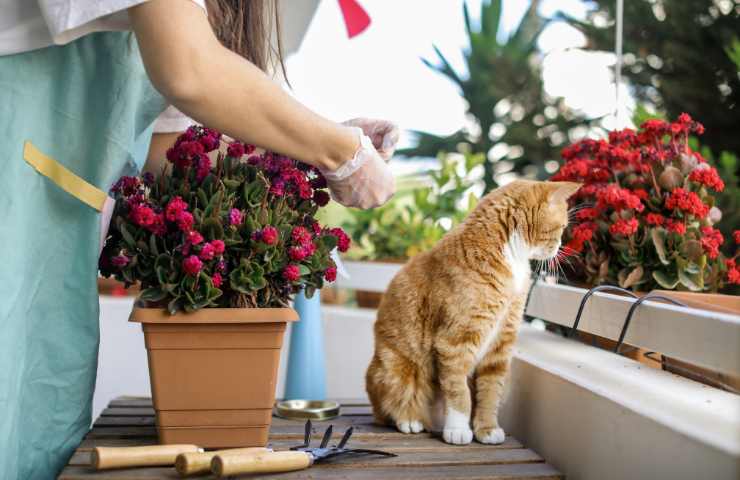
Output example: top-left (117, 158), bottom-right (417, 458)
top-left (59, 463), bottom-right (563, 480)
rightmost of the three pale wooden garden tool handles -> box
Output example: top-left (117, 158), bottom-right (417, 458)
top-left (211, 451), bottom-right (313, 478)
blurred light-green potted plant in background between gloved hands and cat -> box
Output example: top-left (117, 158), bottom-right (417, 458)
top-left (344, 153), bottom-right (485, 308)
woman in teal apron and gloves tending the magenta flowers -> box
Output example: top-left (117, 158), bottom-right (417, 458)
top-left (0, 0), bottom-right (397, 480)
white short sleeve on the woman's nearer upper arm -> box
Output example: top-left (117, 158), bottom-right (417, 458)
top-left (37, 0), bottom-right (206, 45)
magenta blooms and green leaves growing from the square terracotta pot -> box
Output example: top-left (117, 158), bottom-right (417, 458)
top-left (99, 126), bottom-right (350, 314)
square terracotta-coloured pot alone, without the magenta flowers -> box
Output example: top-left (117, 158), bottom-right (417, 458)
top-left (130, 306), bottom-right (298, 448)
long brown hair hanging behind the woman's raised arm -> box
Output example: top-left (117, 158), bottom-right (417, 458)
top-left (206, 0), bottom-right (287, 79)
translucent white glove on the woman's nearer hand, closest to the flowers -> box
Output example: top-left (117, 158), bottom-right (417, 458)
top-left (321, 127), bottom-right (396, 209)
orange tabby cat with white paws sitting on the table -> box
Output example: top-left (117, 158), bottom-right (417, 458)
top-left (366, 180), bottom-right (580, 444)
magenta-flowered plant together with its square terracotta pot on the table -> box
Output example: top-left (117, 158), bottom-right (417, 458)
top-left (100, 127), bottom-right (349, 447)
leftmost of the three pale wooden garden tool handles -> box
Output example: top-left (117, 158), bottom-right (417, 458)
top-left (92, 445), bottom-right (203, 470)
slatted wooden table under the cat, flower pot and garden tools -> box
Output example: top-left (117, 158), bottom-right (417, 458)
top-left (59, 397), bottom-right (564, 480)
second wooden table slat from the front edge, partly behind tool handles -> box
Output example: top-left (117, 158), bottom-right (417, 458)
top-left (69, 448), bottom-right (544, 468)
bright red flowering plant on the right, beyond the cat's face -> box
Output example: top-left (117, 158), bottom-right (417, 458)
top-left (552, 113), bottom-right (740, 291)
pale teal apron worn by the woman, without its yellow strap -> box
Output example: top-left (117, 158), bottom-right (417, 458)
top-left (0, 32), bottom-right (165, 480)
